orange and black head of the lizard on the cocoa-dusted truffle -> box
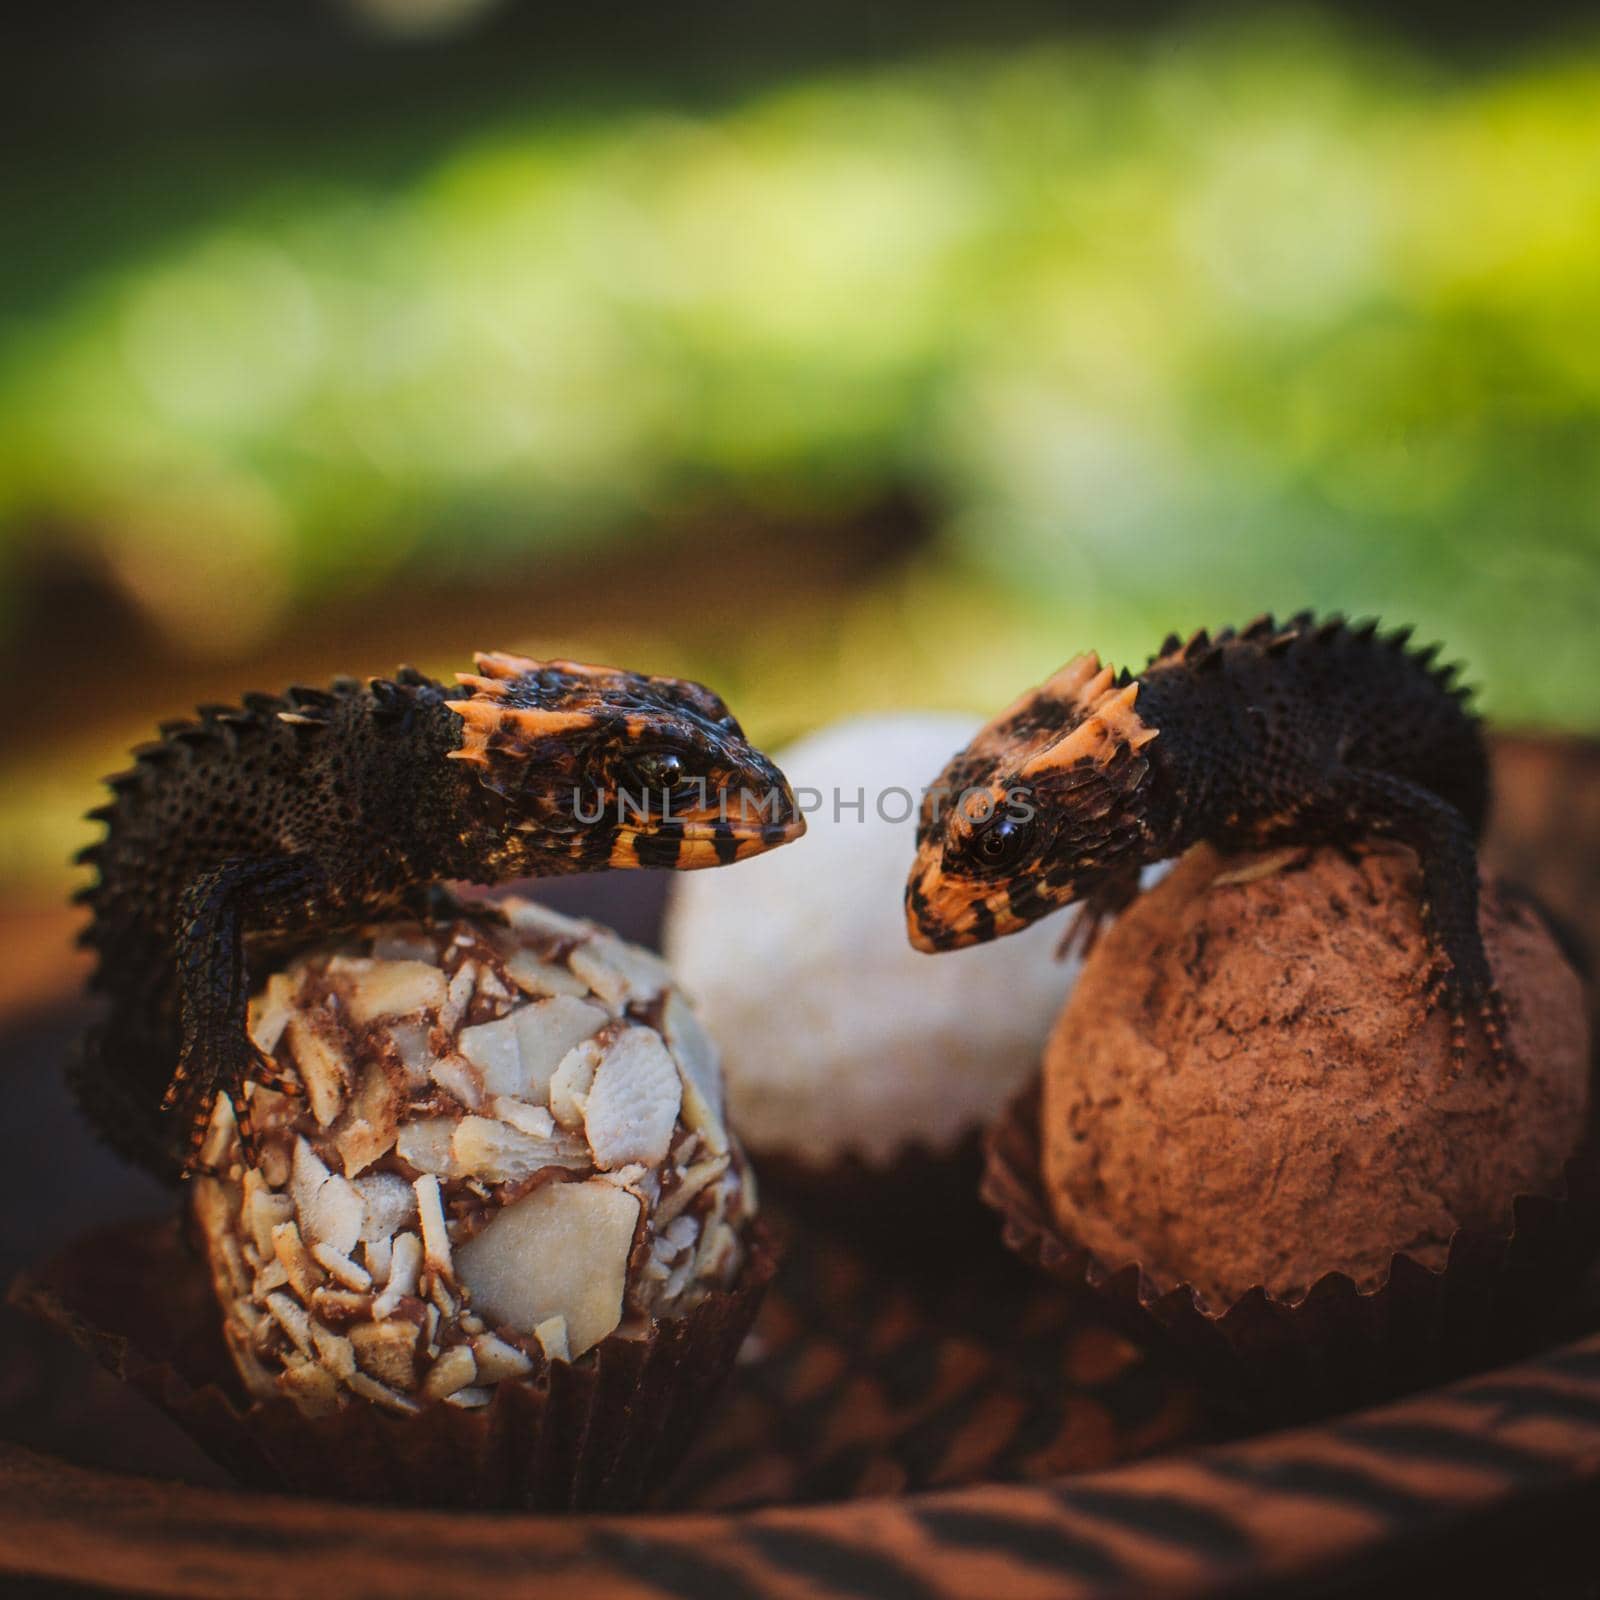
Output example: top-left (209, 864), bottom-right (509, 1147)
top-left (906, 656), bottom-right (1157, 952)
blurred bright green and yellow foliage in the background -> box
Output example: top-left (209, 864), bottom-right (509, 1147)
top-left (0, 14), bottom-right (1600, 728)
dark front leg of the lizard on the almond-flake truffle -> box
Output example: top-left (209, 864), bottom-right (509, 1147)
top-left (162, 856), bottom-right (322, 1174)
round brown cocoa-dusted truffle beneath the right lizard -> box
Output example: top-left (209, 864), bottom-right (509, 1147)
top-left (1042, 848), bottom-right (1589, 1312)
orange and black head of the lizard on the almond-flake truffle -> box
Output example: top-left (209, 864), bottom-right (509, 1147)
top-left (445, 654), bottom-right (805, 872)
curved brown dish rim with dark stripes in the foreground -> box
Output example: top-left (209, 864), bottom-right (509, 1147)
top-left (0, 1336), bottom-right (1600, 1600)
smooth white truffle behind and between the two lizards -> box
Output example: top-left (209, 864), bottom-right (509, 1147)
top-left (666, 715), bottom-right (1100, 1171)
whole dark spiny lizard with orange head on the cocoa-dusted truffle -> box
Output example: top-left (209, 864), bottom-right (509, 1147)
top-left (906, 613), bottom-right (1504, 1067)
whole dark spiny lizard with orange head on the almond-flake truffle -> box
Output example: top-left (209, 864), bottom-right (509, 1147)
top-left (70, 654), bottom-right (805, 1176)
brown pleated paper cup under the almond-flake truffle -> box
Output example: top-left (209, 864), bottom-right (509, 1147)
top-left (10, 1221), bottom-right (778, 1510)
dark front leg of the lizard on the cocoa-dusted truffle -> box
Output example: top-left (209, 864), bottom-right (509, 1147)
top-left (1305, 768), bottom-right (1506, 1072)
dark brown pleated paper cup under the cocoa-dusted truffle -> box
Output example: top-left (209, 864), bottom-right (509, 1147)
top-left (982, 1080), bottom-right (1600, 1421)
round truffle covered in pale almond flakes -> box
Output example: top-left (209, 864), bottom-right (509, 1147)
top-left (194, 901), bottom-right (755, 1414)
